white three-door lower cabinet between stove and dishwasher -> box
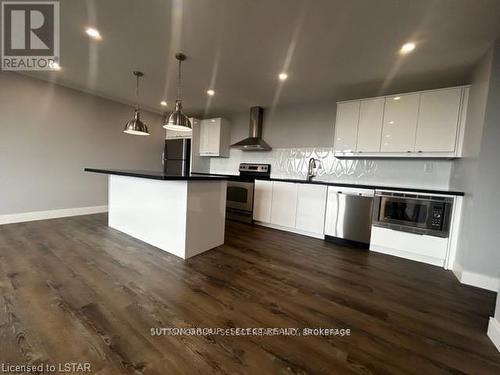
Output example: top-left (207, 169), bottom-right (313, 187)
top-left (253, 180), bottom-right (327, 238)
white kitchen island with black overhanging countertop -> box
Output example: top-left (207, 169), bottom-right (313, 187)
top-left (85, 168), bottom-right (226, 259)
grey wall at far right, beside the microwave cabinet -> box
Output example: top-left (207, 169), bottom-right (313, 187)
top-left (450, 43), bottom-right (500, 277)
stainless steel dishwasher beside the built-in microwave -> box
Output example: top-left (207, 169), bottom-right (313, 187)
top-left (325, 186), bottom-right (375, 248)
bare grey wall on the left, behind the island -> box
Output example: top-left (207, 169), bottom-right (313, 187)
top-left (0, 72), bottom-right (165, 215)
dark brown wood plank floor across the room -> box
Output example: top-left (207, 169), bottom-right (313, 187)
top-left (0, 215), bottom-right (500, 375)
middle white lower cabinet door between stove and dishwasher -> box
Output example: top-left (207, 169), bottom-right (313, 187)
top-left (271, 181), bottom-right (297, 228)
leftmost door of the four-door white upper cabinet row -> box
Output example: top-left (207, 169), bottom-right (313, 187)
top-left (334, 101), bottom-right (360, 152)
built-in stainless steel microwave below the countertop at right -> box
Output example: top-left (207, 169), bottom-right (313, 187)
top-left (372, 191), bottom-right (453, 237)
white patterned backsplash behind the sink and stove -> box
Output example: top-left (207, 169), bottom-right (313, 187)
top-left (210, 147), bottom-right (453, 189)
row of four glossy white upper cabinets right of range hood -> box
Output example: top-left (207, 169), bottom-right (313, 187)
top-left (334, 86), bottom-right (469, 158)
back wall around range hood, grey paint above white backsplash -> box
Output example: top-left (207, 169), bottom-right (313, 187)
top-left (210, 101), bottom-right (453, 190)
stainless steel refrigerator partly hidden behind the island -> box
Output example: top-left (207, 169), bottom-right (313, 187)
top-left (163, 138), bottom-right (191, 175)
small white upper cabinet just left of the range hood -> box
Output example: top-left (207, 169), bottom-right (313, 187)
top-left (200, 118), bottom-right (229, 157)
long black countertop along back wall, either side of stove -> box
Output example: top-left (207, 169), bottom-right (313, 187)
top-left (192, 173), bottom-right (464, 196)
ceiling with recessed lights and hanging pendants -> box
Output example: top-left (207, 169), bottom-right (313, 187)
top-left (21, 0), bottom-right (500, 115)
